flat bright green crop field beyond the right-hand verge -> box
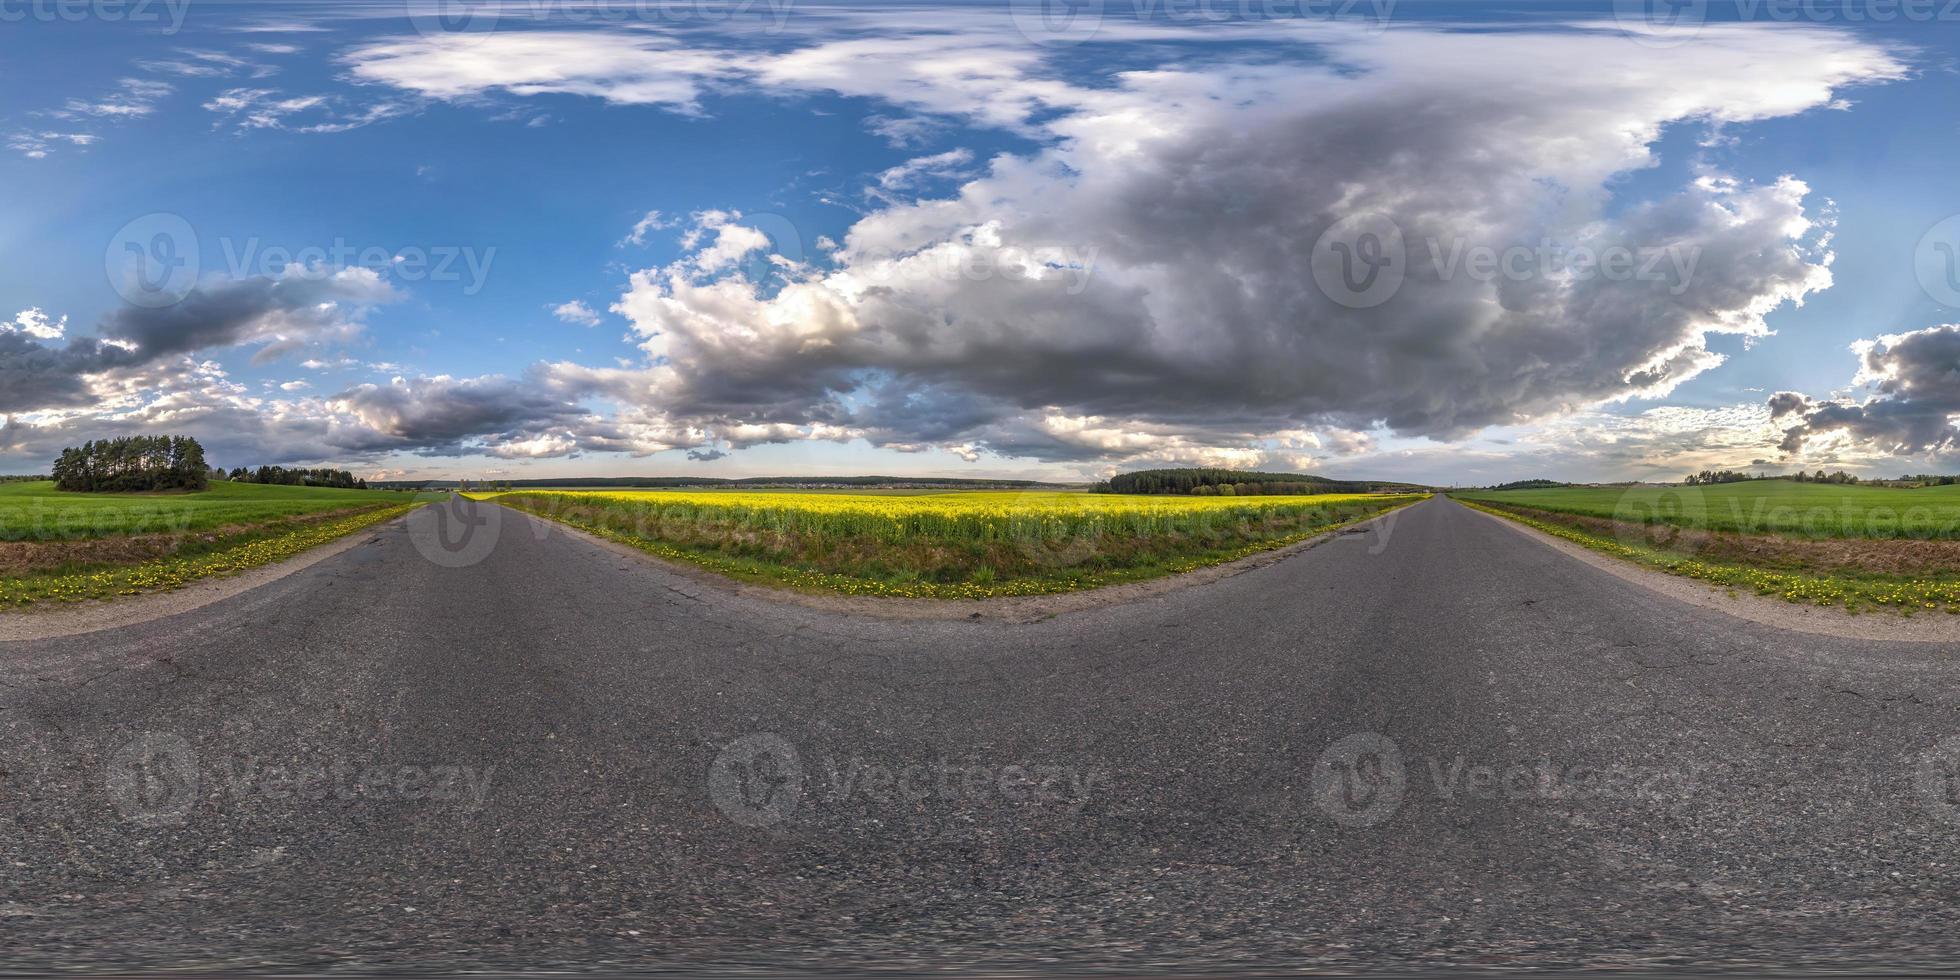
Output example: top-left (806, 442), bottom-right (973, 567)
top-left (1454, 480), bottom-right (1960, 539)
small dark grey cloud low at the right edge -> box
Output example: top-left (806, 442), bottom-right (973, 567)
top-left (1770, 323), bottom-right (1960, 457)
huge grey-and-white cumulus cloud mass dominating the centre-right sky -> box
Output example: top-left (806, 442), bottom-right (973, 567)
top-left (529, 27), bottom-right (1903, 459)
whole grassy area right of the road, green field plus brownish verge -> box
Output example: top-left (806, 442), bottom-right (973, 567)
top-left (1452, 480), bottom-right (1960, 612)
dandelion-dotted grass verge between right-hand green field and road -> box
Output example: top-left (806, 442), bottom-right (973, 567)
top-left (1456, 490), bottom-right (1960, 613)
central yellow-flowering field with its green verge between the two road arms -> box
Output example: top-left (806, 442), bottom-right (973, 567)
top-left (478, 490), bottom-right (1421, 598)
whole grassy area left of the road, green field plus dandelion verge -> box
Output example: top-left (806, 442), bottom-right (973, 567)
top-left (0, 482), bottom-right (429, 608)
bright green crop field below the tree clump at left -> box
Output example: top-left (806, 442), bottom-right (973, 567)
top-left (0, 482), bottom-right (410, 541)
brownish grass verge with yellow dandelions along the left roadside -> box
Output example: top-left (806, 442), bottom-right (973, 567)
top-left (0, 502), bottom-right (419, 610)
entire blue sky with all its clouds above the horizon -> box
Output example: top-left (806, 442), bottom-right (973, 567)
top-left (0, 0), bottom-right (1960, 482)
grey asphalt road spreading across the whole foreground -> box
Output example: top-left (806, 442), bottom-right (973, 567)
top-left (0, 500), bottom-right (1960, 972)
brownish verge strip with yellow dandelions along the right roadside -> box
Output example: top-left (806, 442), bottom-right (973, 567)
top-left (1454, 498), bottom-right (1960, 615)
